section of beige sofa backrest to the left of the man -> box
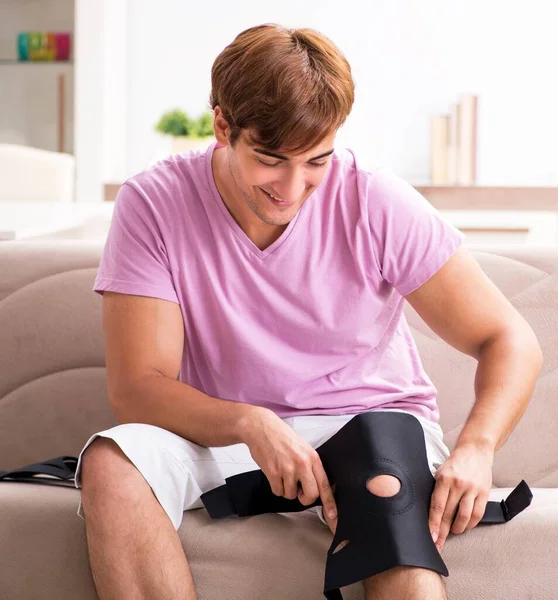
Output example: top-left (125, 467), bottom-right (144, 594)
top-left (0, 241), bottom-right (116, 470)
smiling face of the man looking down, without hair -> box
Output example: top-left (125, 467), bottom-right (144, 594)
top-left (226, 131), bottom-right (335, 226)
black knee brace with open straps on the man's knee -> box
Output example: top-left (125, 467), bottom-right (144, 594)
top-left (201, 411), bottom-right (533, 600)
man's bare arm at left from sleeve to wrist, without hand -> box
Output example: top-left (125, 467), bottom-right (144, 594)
top-left (103, 292), bottom-right (266, 447)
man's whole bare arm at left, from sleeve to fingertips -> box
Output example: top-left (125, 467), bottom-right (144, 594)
top-left (103, 292), bottom-right (342, 516)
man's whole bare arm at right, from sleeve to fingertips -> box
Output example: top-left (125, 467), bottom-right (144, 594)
top-left (406, 246), bottom-right (543, 551)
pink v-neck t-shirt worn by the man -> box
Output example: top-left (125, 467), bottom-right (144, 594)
top-left (94, 144), bottom-right (464, 423)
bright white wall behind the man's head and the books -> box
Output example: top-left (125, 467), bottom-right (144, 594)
top-left (82, 0), bottom-right (558, 196)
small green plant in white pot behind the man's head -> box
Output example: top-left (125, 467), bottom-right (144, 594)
top-left (155, 108), bottom-right (215, 154)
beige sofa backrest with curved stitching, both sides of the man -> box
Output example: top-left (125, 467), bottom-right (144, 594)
top-left (0, 241), bottom-right (558, 487)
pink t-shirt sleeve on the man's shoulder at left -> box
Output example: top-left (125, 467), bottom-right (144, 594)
top-left (93, 183), bottom-right (179, 304)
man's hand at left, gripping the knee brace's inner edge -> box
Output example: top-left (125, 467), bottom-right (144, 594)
top-left (244, 409), bottom-right (337, 520)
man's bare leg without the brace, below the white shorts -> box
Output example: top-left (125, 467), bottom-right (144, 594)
top-left (81, 437), bottom-right (196, 600)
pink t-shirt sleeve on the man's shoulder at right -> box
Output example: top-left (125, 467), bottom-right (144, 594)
top-left (364, 167), bottom-right (465, 296)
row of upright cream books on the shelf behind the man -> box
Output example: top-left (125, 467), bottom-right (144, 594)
top-left (430, 94), bottom-right (478, 185)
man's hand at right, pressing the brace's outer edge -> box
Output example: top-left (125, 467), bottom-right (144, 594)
top-left (429, 445), bottom-right (494, 552)
